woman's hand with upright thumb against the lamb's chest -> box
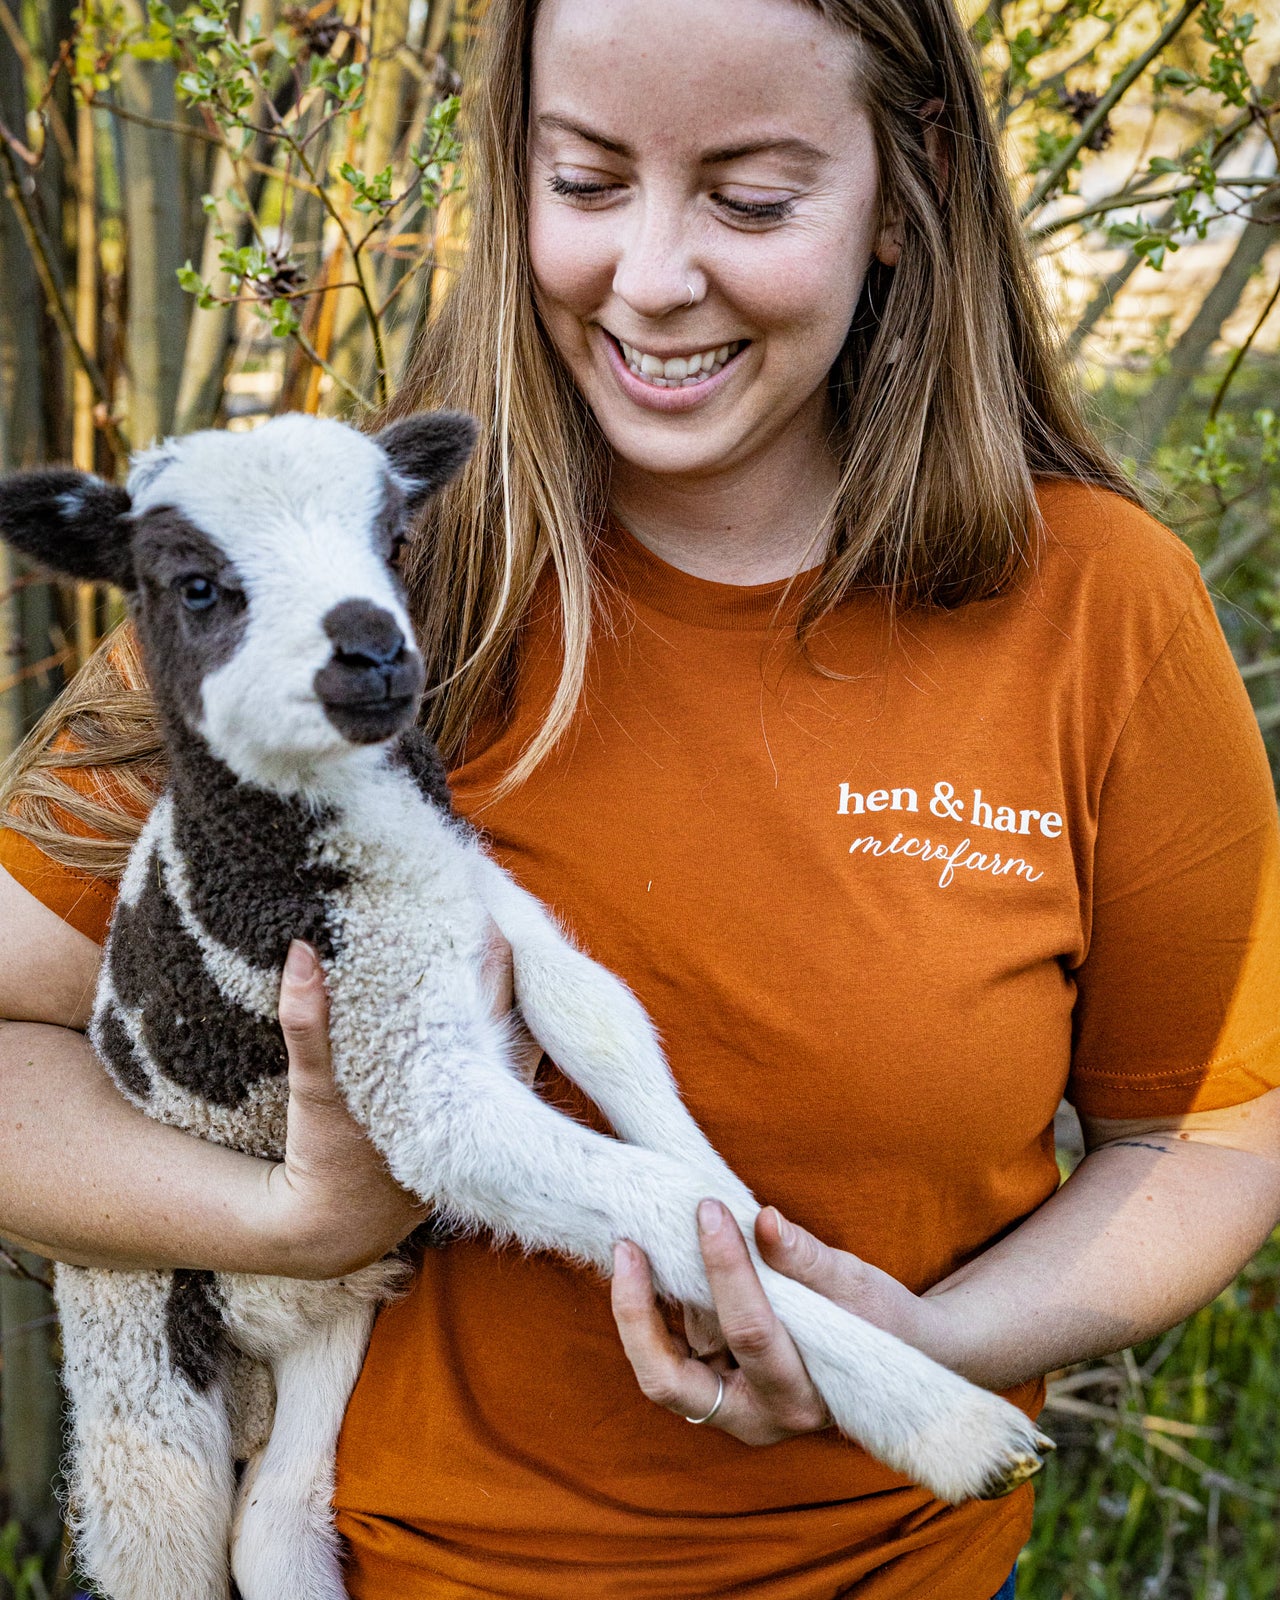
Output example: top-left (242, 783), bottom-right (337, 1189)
top-left (258, 939), bottom-right (426, 1277)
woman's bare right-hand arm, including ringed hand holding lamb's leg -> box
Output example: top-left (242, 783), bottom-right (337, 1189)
top-left (613, 1090), bottom-right (1280, 1443)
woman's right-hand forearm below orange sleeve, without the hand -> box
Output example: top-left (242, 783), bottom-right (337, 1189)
top-left (920, 1133), bottom-right (1280, 1389)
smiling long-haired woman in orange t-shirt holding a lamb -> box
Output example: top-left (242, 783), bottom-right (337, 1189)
top-left (0, 0), bottom-right (1280, 1600)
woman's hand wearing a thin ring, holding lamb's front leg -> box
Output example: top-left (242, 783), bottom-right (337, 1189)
top-left (611, 1200), bottom-right (947, 1445)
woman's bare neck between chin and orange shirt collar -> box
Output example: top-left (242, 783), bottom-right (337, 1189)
top-left (610, 406), bottom-right (838, 584)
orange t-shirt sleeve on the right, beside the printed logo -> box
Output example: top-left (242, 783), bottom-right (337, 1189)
top-left (1067, 582), bottom-right (1280, 1118)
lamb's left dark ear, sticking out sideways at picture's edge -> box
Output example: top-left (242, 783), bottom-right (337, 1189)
top-left (0, 467), bottom-right (134, 589)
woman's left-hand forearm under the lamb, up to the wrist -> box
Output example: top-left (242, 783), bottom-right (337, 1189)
top-left (0, 1022), bottom-right (292, 1272)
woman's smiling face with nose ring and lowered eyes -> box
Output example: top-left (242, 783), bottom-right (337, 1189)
top-left (530, 0), bottom-right (891, 477)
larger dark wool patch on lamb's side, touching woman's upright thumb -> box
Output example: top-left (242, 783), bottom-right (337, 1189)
top-left (110, 856), bottom-right (288, 1106)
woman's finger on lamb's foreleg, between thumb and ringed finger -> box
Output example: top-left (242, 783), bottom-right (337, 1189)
top-left (698, 1200), bottom-right (827, 1434)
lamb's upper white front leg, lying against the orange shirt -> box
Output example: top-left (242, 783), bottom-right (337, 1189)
top-left (482, 858), bottom-right (754, 1205)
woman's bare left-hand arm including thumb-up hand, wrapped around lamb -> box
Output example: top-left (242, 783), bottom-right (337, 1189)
top-left (0, 870), bottom-right (421, 1278)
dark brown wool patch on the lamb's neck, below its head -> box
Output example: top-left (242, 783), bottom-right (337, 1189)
top-left (170, 728), bottom-right (347, 968)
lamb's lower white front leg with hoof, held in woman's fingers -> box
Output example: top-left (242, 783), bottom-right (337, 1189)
top-left (371, 1029), bottom-right (1042, 1501)
